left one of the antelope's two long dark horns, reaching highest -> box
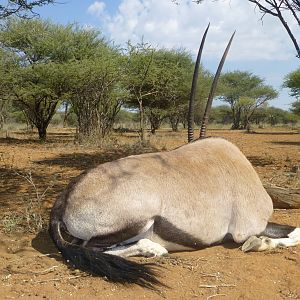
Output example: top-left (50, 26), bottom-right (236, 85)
top-left (188, 23), bottom-right (210, 143)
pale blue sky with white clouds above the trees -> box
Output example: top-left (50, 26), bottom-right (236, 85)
top-left (37, 0), bottom-right (300, 110)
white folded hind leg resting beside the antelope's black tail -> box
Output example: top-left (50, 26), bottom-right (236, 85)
top-left (104, 239), bottom-right (168, 257)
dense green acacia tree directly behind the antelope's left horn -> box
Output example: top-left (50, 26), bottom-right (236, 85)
top-left (125, 49), bottom-right (210, 134)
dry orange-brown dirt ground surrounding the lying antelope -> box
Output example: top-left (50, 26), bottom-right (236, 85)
top-left (0, 129), bottom-right (300, 300)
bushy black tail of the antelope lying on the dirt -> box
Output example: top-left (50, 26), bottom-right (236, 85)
top-left (49, 218), bottom-right (163, 289)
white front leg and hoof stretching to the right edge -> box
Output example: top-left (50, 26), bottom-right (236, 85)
top-left (242, 228), bottom-right (300, 252)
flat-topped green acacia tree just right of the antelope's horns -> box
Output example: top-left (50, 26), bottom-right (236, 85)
top-left (219, 71), bottom-right (278, 129)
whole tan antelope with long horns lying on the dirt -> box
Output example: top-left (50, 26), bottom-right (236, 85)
top-left (50, 26), bottom-right (300, 287)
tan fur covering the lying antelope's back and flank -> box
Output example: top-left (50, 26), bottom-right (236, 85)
top-left (54, 138), bottom-right (273, 251)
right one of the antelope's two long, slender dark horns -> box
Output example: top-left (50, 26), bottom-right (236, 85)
top-left (200, 31), bottom-right (235, 139)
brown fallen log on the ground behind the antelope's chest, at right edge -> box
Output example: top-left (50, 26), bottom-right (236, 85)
top-left (264, 184), bottom-right (300, 208)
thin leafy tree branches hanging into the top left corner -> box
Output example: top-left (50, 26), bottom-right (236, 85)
top-left (0, 0), bottom-right (54, 19)
